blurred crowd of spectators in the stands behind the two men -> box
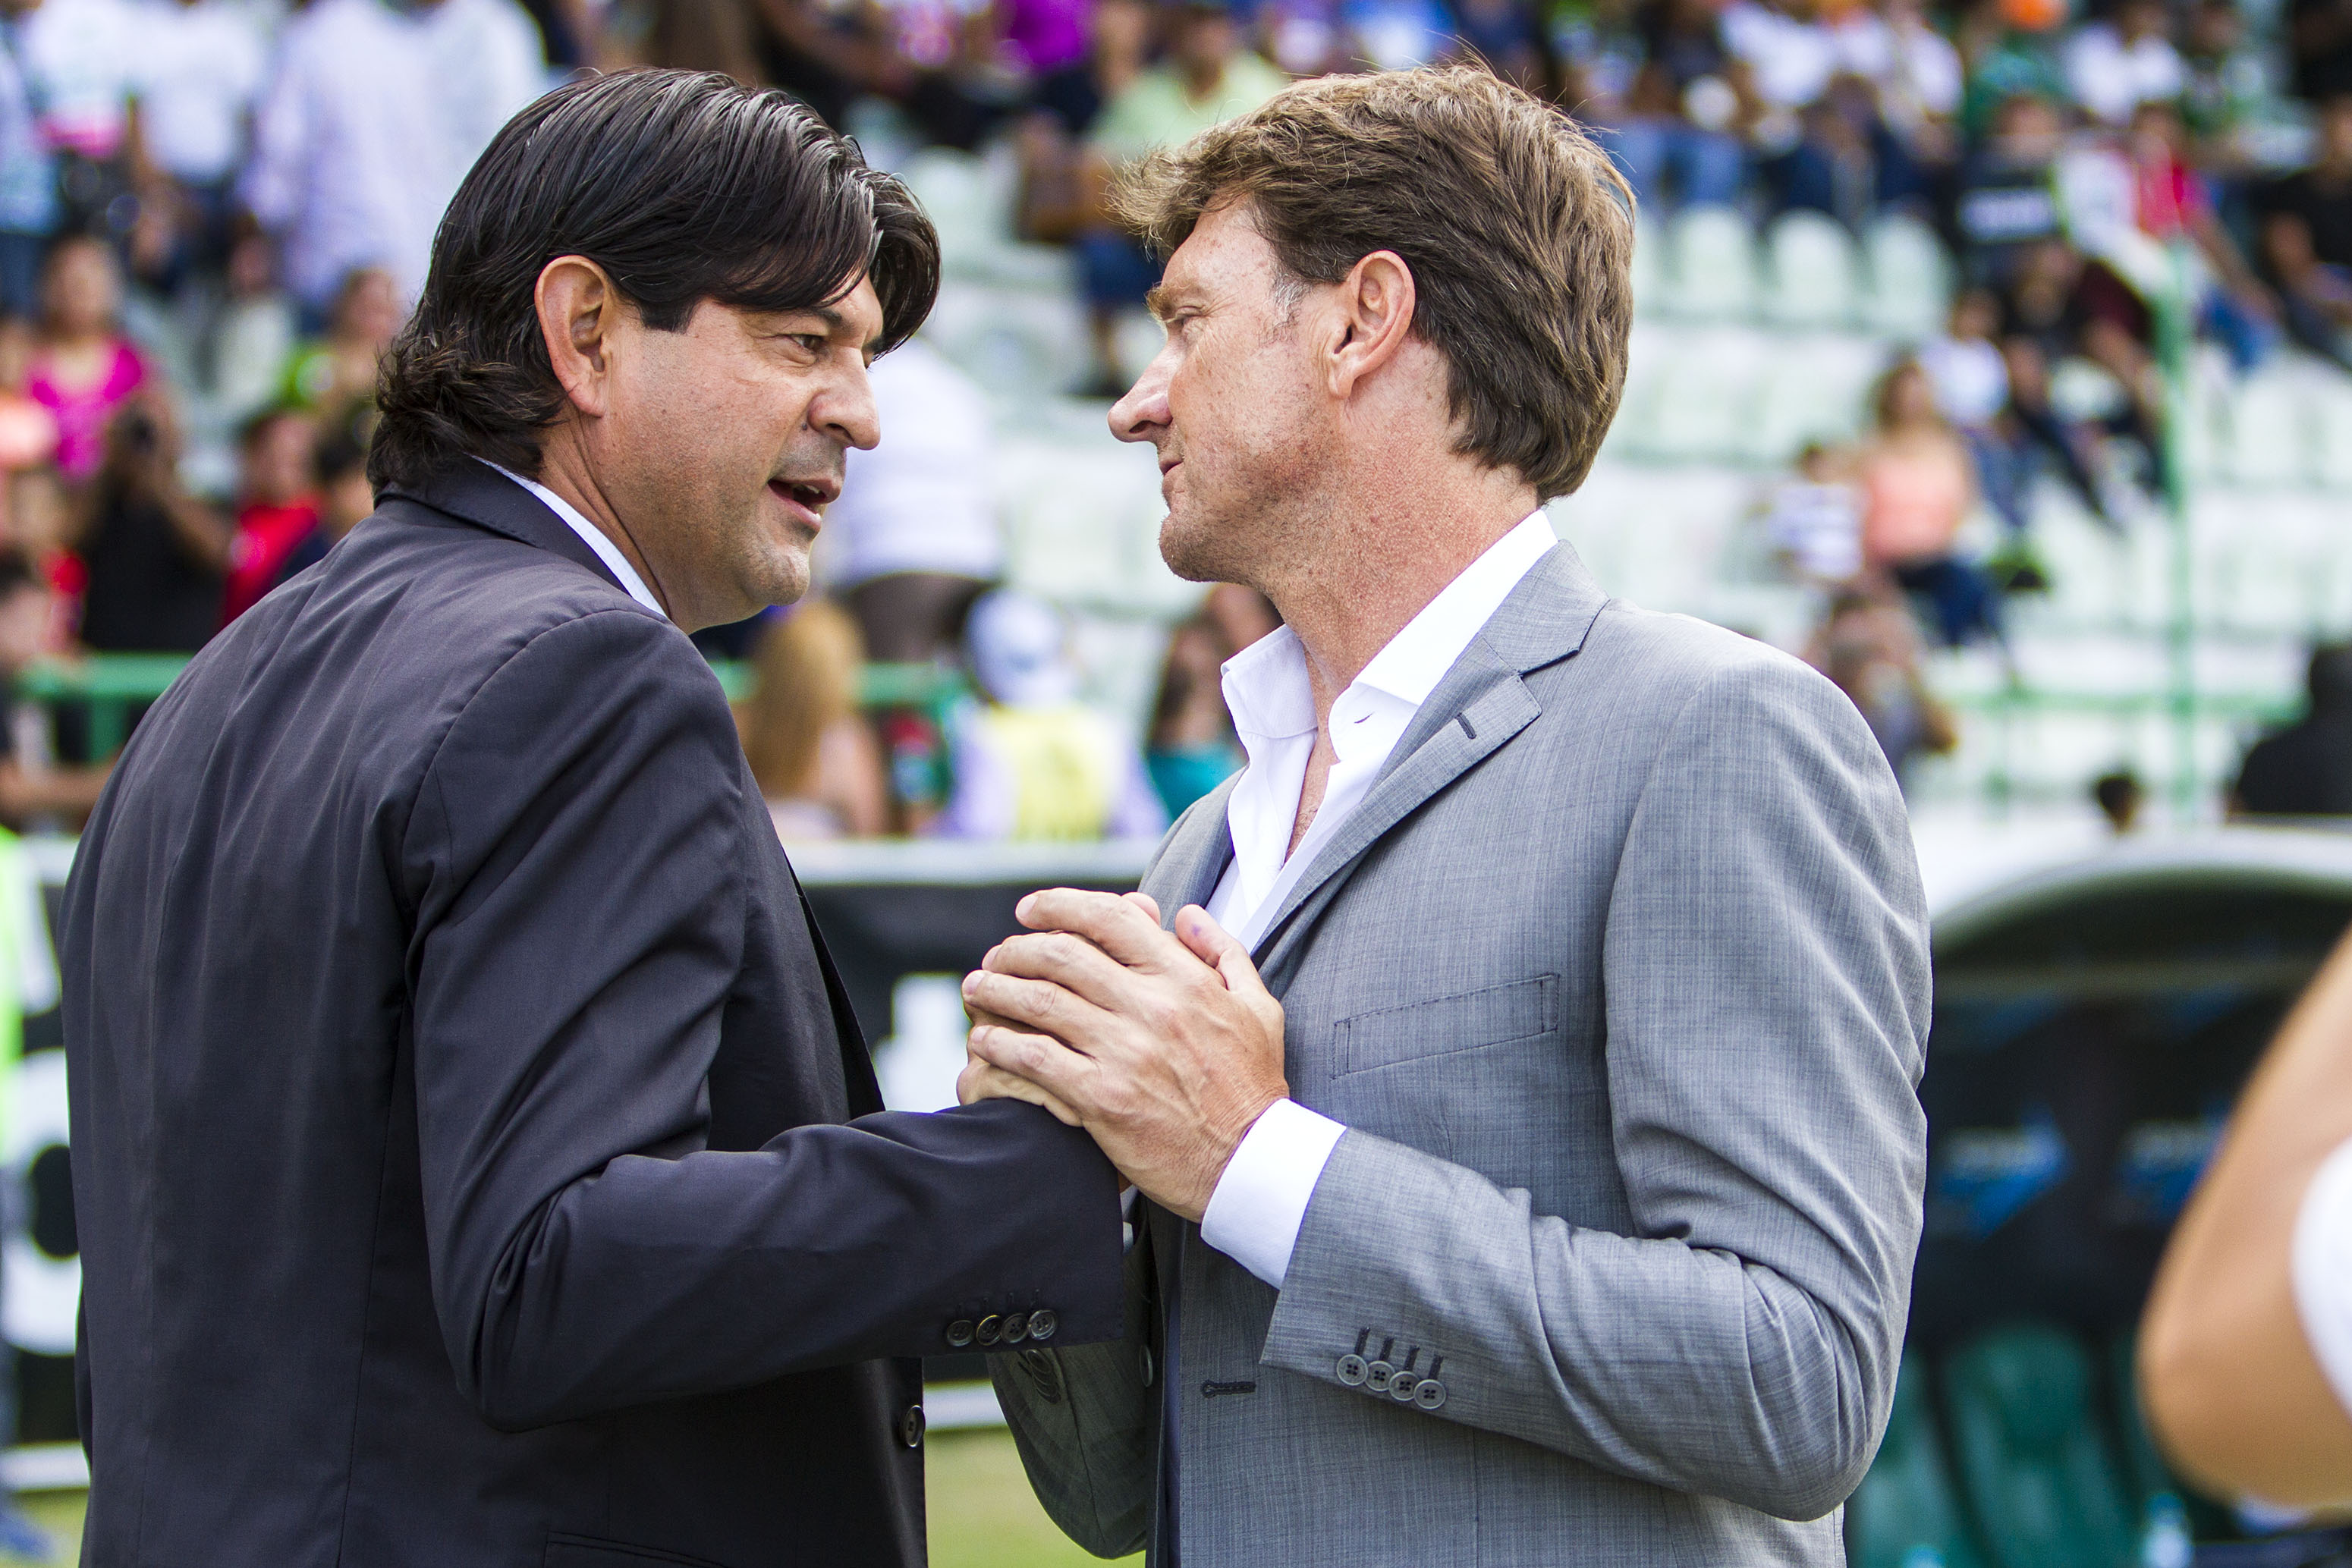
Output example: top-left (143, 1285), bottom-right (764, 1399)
top-left (0, 0), bottom-right (2323, 839)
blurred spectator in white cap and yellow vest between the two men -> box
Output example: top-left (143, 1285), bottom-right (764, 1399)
top-left (932, 592), bottom-right (1169, 841)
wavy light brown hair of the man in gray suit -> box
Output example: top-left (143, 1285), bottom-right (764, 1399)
top-left (1112, 66), bottom-right (1632, 501)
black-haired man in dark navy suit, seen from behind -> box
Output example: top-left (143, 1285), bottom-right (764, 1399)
top-left (64, 73), bottom-right (1120, 1568)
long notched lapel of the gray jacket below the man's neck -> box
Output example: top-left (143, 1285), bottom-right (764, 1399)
top-left (1253, 543), bottom-right (1608, 973)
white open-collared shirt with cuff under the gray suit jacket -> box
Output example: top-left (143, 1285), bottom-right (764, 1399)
top-left (1200, 513), bottom-right (1559, 1290)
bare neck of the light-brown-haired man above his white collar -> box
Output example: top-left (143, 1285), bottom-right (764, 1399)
top-left (1261, 470), bottom-right (1536, 727)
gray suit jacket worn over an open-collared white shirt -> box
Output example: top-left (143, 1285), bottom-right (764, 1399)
top-left (995, 545), bottom-right (1929, 1568)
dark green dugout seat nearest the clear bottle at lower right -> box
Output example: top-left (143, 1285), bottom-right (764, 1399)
top-left (1945, 1324), bottom-right (2136, 1568)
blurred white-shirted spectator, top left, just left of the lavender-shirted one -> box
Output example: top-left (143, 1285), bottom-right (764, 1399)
top-left (132, 0), bottom-right (268, 278)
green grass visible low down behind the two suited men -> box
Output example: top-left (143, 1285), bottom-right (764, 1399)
top-left (0, 1429), bottom-right (1143, 1568)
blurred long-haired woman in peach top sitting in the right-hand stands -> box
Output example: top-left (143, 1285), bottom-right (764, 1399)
top-left (1856, 360), bottom-right (1999, 646)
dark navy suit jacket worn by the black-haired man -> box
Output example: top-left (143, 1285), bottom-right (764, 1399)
top-left (64, 458), bottom-right (1122, 1568)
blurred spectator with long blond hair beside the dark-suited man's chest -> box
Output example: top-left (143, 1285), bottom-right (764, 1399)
top-left (736, 599), bottom-right (889, 841)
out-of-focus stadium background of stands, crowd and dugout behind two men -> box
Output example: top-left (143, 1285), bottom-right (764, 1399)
top-left (0, 0), bottom-right (2352, 1568)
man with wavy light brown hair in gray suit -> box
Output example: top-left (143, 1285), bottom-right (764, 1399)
top-left (945, 71), bottom-right (1929, 1568)
